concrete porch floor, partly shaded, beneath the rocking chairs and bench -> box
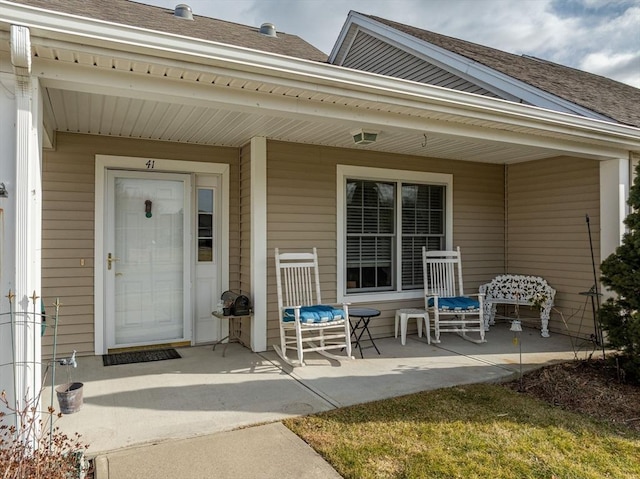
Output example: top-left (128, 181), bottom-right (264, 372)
top-left (43, 324), bottom-right (585, 456)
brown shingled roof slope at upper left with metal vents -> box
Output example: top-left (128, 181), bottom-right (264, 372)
top-left (11, 0), bottom-right (327, 62)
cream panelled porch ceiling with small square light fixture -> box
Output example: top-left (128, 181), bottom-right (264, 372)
top-left (45, 88), bottom-right (564, 163)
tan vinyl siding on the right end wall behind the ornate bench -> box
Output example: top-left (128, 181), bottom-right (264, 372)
top-left (506, 157), bottom-right (600, 337)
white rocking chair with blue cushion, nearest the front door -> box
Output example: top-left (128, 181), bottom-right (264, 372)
top-left (273, 248), bottom-right (354, 366)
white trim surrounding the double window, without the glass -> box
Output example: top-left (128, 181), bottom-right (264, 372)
top-left (336, 165), bottom-right (453, 303)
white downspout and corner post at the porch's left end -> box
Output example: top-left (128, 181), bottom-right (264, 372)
top-left (4, 25), bottom-right (42, 439)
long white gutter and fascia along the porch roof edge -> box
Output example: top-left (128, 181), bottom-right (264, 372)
top-left (0, 0), bottom-right (640, 151)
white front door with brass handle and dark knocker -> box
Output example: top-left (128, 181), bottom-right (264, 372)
top-left (105, 170), bottom-right (191, 349)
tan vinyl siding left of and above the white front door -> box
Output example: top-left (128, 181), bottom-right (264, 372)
top-left (42, 133), bottom-right (239, 357)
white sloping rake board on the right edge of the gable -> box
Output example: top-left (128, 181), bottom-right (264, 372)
top-left (340, 13), bottom-right (614, 121)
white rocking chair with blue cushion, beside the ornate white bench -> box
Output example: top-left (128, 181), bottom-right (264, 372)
top-left (422, 247), bottom-right (485, 343)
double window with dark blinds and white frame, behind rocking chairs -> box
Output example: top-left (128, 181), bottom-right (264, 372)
top-left (338, 165), bottom-right (452, 297)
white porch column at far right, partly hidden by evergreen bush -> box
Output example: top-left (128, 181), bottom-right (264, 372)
top-left (600, 158), bottom-right (631, 268)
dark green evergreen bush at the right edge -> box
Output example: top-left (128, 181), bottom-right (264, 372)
top-left (598, 160), bottom-right (640, 383)
